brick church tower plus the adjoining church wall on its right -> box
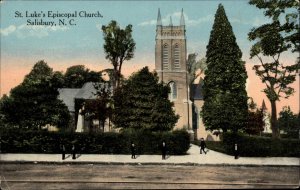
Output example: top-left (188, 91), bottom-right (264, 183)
top-left (155, 10), bottom-right (218, 140)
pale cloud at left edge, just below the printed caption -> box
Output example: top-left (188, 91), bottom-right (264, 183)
top-left (0, 24), bottom-right (69, 38)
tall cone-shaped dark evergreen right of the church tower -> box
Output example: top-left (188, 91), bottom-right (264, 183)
top-left (201, 4), bottom-right (248, 132)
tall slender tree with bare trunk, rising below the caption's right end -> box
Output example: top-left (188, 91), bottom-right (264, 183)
top-left (102, 20), bottom-right (135, 89)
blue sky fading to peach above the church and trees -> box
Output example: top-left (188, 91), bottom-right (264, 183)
top-left (0, 0), bottom-right (299, 113)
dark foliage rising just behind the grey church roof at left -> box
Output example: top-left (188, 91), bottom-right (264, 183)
top-left (64, 65), bottom-right (101, 88)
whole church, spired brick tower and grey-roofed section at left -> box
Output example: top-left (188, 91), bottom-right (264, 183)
top-left (59, 10), bottom-right (219, 140)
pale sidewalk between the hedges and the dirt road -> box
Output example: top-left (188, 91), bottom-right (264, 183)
top-left (0, 145), bottom-right (300, 167)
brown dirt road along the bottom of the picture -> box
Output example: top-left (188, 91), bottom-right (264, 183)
top-left (1, 164), bottom-right (300, 190)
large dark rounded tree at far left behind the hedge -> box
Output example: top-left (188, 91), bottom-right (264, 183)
top-left (0, 61), bottom-right (70, 129)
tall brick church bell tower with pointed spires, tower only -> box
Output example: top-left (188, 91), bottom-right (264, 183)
top-left (155, 9), bottom-right (192, 129)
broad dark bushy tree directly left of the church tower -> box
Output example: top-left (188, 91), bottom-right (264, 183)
top-left (112, 67), bottom-right (179, 131)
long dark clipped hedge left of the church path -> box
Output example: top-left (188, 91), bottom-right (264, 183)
top-left (0, 129), bottom-right (190, 155)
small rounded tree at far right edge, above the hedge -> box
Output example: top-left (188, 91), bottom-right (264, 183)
top-left (278, 106), bottom-right (300, 136)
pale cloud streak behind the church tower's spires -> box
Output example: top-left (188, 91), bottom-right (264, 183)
top-left (138, 12), bottom-right (213, 26)
